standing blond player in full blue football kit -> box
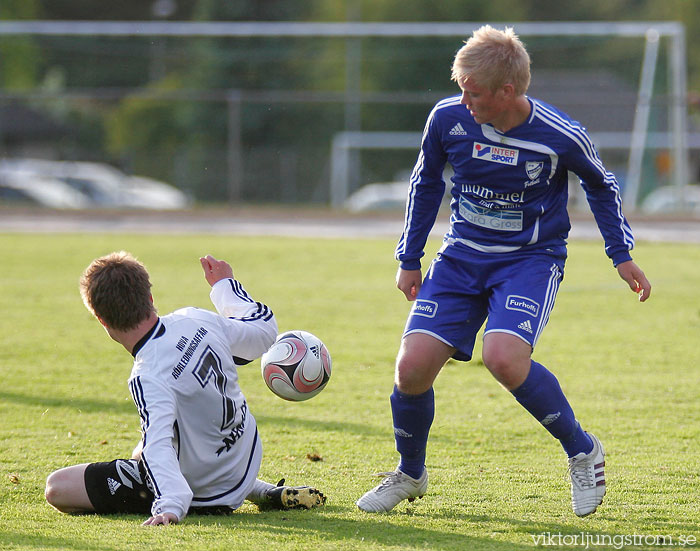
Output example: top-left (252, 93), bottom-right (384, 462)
top-left (357, 25), bottom-right (651, 516)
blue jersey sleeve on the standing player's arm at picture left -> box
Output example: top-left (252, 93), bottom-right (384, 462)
top-left (396, 106), bottom-right (447, 270)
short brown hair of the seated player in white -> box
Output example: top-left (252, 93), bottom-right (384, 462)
top-left (80, 251), bottom-right (156, 331)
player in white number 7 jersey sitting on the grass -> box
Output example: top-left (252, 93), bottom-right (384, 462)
top-left (46, 252), bottom-right (325, 525)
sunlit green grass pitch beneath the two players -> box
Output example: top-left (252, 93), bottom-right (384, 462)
top-left (0, 234), bottom-right (700, 551)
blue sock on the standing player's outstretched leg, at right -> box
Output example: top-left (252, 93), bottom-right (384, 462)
top-left (512, 361), bottom-right (593, 457)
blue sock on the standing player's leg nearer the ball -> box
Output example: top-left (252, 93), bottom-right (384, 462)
top-left (390, 386), bottom-right (435, 478)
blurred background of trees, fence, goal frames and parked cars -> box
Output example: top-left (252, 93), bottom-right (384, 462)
top-left (0, 0), bottom-right (700, 216)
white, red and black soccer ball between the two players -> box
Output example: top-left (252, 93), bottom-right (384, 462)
top-left (260, 331), bottom-right (331, 402)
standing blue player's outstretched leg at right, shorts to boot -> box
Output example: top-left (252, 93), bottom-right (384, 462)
top-left (483, 257), bottom-right (605, 516)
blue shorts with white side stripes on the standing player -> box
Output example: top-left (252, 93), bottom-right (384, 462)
top-left (404, 251), bottom-right (566, 361)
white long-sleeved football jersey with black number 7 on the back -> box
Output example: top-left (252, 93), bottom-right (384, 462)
top-left (129, 279), bottom-right (277, 519)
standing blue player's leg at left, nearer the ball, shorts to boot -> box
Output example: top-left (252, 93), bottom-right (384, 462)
top-left (357, 257), bottom-right (486, 512)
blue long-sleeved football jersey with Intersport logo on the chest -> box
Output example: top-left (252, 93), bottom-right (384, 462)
top-left (396, 96), bottom-right (634, 270)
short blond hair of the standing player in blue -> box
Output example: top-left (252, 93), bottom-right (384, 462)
top-left (452, 25), bottom-right (530, 95)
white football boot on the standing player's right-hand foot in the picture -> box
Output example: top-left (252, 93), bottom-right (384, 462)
top-left (569, 433), bottom-right (605, 517)
